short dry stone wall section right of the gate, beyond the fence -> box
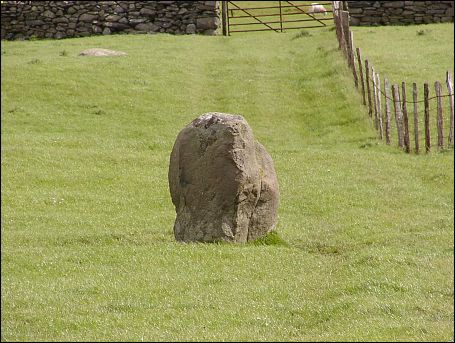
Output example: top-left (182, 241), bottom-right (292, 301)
top-left (348, 1), bottom-right (454, 26)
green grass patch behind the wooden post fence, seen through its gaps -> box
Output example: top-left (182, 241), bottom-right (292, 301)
top-left (351, 23), bottom-right (454, 156)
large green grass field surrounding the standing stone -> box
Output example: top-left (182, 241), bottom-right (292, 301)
top-left (1, 25), bottom-right (454, 341)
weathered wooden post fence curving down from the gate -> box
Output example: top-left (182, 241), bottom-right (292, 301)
top-left (333, 1), bottom-right (455, 153)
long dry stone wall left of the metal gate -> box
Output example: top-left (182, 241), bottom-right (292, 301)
top-left (1, 1), bottom-right (220, 40)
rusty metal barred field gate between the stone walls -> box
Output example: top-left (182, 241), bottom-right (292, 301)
top-left (222, 1), bottom-right (334, 35)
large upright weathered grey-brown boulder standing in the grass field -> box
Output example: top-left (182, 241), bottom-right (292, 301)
top-left (169, 112), bottom-right (279, 242)
